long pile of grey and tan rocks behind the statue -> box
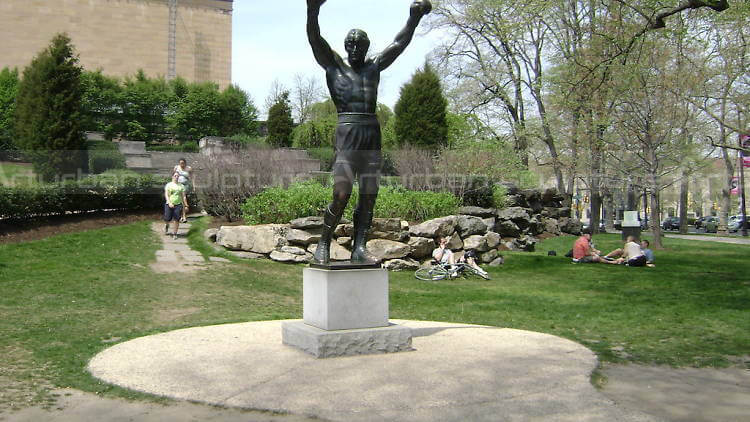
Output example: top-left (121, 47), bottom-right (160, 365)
top-left (206, 189), bottom-right (581, 270)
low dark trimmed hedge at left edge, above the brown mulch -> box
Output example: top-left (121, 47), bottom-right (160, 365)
top-left (0, 172), bottom-right (167, 219)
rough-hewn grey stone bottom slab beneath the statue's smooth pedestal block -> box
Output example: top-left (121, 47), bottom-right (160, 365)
top-left (281, 321), bottom-right (413, 358)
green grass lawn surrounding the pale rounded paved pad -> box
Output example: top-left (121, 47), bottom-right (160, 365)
top-left (0, 223), bottom-right (750, 410)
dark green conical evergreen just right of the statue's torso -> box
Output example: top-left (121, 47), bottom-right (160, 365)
top-left (394, 63), bottom-right (448, 148)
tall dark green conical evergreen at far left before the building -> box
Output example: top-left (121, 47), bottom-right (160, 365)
top-left (15, 34), bottom-right (86, 181)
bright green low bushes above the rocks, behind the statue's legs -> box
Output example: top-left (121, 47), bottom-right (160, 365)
top-left (242, 181), bottom-right (459, 224)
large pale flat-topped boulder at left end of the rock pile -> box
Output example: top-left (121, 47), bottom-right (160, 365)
top-left (216, 224), bottom-right (289, 254)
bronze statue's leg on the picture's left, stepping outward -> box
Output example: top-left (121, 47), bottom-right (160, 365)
top-left (313, 162), bottom-right (354, 264)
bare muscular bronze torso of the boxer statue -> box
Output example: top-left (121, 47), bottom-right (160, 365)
top-left (326, 59), bottom-right (380, 113)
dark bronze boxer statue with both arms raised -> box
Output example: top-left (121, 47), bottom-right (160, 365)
top-left (307, 0), bottom-right (432, 264)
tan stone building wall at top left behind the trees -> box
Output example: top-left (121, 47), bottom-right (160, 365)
top-left (0, 0), bottom-right (232, 88)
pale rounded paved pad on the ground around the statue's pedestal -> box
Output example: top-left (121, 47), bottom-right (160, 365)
top-left (88, 320), bottom-right (660, 422)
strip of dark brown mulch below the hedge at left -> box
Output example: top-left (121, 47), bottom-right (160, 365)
top-left (0, 211), bottom-right (161, 244)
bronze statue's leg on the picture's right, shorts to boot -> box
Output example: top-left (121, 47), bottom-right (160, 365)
top-left (352, 154), bottom-right (380, 262)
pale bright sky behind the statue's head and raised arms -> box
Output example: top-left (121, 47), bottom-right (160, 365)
top-left (232, 0), bottom-right (438, 112)
